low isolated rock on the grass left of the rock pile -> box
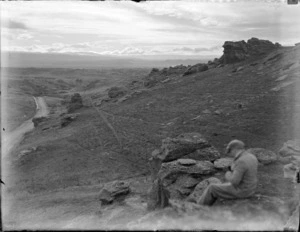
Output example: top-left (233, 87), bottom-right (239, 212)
top-left (99, 180), bottom-right (130, 205)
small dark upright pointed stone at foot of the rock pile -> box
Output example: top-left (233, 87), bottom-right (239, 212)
top-left (147, 178), bottom-right (170, 210)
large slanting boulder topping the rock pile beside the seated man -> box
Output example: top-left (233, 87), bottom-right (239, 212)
top-left (152, 133), bottom-right (211, 162)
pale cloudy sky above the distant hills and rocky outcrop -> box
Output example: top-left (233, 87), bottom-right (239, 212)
top-left (0, 0), bottom-right (300, 59)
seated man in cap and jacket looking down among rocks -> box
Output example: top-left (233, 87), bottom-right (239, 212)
top-left (198, 140), bottom-right (258, 205)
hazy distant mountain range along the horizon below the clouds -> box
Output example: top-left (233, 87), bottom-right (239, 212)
top-left (1, 52), bottom-right (215, 68)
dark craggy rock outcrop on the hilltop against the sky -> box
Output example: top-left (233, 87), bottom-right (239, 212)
top-left (220, 38), bottom-right (281, 64)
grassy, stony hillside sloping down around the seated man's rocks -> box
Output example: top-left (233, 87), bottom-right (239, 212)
top-left (4, 44), bottom-right (300, 229)
